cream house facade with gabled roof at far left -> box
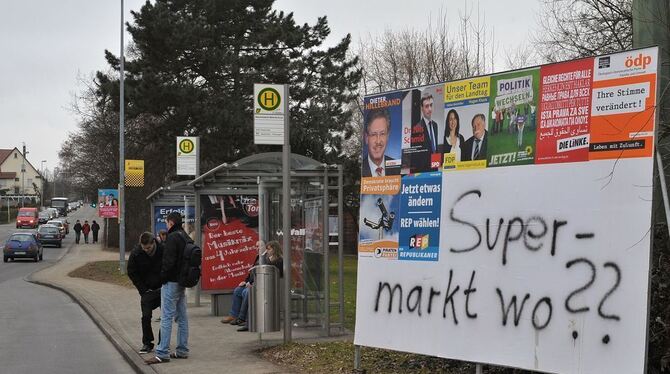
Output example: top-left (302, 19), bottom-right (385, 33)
top-left (0, 148), bottom-right (44, 195)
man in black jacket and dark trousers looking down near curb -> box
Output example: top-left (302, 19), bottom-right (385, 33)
top-left (128, 232), bottom-right (163, 353)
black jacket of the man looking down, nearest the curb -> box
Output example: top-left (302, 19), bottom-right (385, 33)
top-left (128, 240), bottom-right (164, 295)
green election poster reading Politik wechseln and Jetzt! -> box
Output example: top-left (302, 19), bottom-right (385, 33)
top-left (484, 69), bottom-right (540, 167)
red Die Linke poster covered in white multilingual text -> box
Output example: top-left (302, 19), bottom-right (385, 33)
top-left (535, 58), bottom-right (593, 164)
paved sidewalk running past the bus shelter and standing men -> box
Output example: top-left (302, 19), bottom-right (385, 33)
top-left (28, 244), bottom-right (296, 374)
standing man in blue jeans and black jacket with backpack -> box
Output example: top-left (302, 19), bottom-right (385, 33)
top-left (146, 212), bottom-right (189, 365)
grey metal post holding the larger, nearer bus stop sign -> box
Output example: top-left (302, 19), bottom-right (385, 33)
top-left (282, 84), bottom-right (291, 343)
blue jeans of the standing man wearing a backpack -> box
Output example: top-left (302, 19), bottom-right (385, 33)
top-left (156, 282), bottom-right (189, 358)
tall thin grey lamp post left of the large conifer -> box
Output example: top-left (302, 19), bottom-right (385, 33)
top-left (119, 0), bottom-right (126, 274)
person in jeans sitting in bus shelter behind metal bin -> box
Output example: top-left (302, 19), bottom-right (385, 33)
top-left (221, 240), bottom-right (284, 331)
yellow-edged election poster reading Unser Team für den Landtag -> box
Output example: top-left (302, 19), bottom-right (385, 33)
top-left (442, 77), bottom-right (491, 171)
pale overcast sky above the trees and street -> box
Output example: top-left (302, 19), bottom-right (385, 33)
top-left (0, 0), bottom-right (540, 175)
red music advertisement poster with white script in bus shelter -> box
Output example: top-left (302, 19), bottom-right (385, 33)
top-left (200, 195), bottom-right (259, 291)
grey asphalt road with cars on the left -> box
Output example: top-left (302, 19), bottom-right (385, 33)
top-left (0, 207), bottom-right (134, 374)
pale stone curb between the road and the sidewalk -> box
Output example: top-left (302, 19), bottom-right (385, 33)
top-left (23, 231), bottom-right (158, 374)
